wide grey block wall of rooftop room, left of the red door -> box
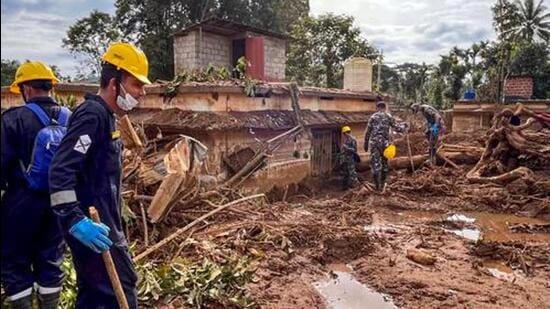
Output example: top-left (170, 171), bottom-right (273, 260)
top-left (174, 31), bottom-right (231, 73)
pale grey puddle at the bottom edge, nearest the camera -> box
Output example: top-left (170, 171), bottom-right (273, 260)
top-left (313, 271), bottom-right (397, 309)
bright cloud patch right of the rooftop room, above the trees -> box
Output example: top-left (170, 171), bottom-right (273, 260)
top-left (310, 0), bottom-right (495, 63)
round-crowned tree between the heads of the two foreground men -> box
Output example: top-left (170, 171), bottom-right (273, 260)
top-left (63, 10), bottom-right (122, 76)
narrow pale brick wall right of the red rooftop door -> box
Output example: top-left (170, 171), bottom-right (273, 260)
top-left (264, 37), bottom-right (286, 81)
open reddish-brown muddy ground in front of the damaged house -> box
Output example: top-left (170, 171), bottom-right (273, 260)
top-left (139, 131), bottom-right (550, 308)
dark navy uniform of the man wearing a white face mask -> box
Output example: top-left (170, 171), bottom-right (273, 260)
top-left (50, 94), bottom-right (137, 308)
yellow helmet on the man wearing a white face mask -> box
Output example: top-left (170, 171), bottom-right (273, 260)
top-left (101, 42), bottom-right (151, 84)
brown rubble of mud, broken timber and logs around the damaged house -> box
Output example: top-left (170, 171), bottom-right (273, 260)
top-left (109, 110), bottom-right (550, 308)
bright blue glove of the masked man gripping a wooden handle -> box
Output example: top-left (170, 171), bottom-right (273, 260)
top-left (69, 218), bottom-right (113, 253)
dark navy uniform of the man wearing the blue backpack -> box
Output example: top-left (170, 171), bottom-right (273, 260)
top-left (1, 97), bottom-right (65, 296)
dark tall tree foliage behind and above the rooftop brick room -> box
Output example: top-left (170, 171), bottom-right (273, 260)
top-left (115, 0), bottom-right (309, 80)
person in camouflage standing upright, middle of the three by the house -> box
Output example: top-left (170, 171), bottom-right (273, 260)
top-left (364, 101), bottom-right (408, 192)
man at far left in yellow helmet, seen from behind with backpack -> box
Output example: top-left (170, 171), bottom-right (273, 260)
top-left (1, 61), bottom-right (66, 309)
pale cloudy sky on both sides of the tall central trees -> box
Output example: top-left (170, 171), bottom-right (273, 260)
top-left (1, 0), bottom-right (495, 75)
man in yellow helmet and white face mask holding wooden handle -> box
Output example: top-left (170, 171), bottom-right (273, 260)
top-left (50, 42), bottom-right (150, 308)
